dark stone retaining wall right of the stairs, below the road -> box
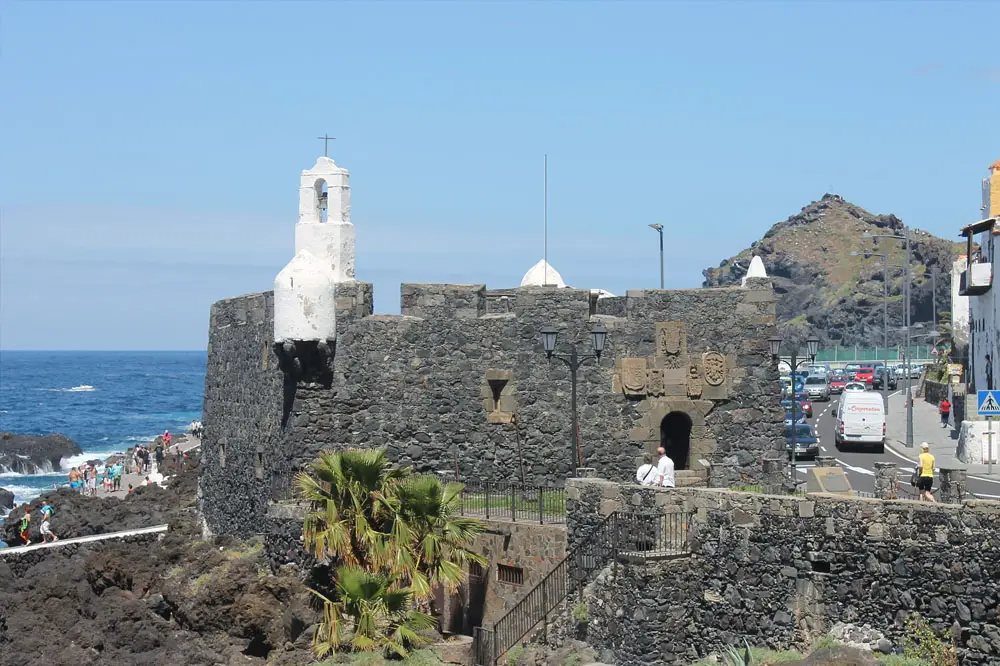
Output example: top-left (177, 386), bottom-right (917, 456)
top-left (567, 479), bottom-right (1000, 666)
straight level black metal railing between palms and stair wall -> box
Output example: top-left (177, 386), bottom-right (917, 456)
top-left (459, 481), bottom-right (566, 524)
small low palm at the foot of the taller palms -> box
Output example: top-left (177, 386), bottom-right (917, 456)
top-left (313, 566), bottom-right (434, 657)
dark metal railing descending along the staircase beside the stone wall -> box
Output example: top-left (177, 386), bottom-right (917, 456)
top-left (473, 513), bottom-right (691, 666)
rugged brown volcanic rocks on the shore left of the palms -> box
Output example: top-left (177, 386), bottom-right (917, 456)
top-left (0, 452), bottom-right (318, 666)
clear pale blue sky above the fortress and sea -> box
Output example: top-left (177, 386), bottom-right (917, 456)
top-left (0, 0), bottom-right (1000, 349)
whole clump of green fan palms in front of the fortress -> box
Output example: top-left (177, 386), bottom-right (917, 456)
top-left (295, 449), bottom-right (486, 655)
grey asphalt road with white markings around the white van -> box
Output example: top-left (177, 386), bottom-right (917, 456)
top-left (798, 391), bottom-right (1000, 499)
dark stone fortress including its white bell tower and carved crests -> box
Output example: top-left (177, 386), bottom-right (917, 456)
top-left (199, 157), bottom-right (785, 536)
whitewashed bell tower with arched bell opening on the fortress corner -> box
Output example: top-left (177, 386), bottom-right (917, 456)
top-left (274, 157), bottom-right (354, 343)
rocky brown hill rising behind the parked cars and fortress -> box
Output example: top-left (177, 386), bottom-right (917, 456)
top-left (703, 194), bottom-right (963, 347)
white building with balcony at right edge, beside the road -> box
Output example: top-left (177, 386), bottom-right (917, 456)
top-left (956, 160), bottom-right (1000, 463)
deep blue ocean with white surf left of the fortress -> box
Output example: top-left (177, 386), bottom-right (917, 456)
top-left (0, 351), bottom-right (206, 503)
